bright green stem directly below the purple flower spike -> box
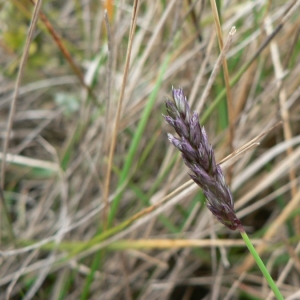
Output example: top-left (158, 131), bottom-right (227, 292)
top-left (239, 228), bottom-right (284, 300)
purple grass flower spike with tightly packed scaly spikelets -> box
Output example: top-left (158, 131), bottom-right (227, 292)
top-left (165, 88), bottom-right (242, 230)
